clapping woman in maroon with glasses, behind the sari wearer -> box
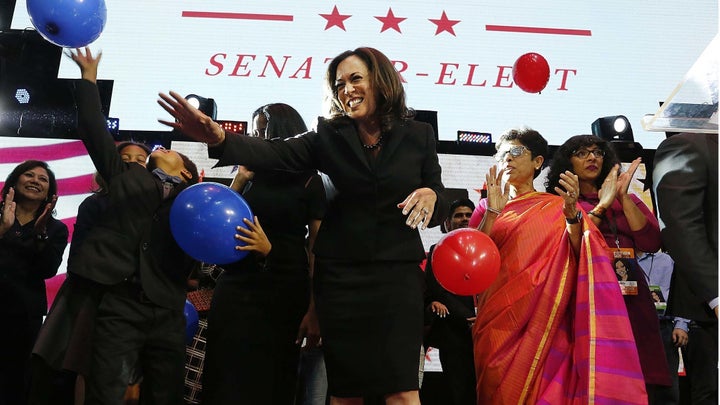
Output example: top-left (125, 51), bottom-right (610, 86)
top-left (546, 135), bottom-right (672, 403)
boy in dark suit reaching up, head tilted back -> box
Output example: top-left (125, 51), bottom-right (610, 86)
top-left (29, 48), bottom-right (264, 405)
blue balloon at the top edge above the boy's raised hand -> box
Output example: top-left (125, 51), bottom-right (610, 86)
top-left (27, 0), bottom-right (107, 48)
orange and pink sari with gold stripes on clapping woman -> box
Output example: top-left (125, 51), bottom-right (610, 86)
top-left (473, 192), bottom-right (647, 405)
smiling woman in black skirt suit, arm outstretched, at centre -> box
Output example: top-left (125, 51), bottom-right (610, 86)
top-left (158, 48), bottom-right (444, 404)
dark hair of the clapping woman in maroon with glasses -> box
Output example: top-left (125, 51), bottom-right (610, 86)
top-left (545, 135), bottom-right (620, 194)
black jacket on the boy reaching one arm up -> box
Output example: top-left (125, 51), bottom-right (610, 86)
top-left (68, 80), bottom-right (195, 310)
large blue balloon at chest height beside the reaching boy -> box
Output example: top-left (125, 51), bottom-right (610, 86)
top-left (170, 182), bottom-right (253, 264)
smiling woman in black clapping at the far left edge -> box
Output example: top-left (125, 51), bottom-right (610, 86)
top-left (0, 160), bottom-right (68, 404)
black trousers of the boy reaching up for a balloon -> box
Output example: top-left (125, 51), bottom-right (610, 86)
top-left (85, 285), bottom-right (185, 405)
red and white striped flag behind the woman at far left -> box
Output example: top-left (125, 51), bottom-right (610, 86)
top-left (0, 137), bottom-right (95, 305)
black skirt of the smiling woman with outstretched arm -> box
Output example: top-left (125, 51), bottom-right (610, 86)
top-left (314, 258), bottom-right (424, 397)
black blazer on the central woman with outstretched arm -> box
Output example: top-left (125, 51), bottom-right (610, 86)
top-left (210, 117), bottom-right (447, 262)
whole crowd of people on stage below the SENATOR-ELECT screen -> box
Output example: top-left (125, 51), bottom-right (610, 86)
top-left (0, 43), bottom-right (718, 405)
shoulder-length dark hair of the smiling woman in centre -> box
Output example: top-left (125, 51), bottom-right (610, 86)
top-left (325, 47), bottom-right (412, 131)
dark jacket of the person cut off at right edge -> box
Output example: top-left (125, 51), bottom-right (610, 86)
top-left (653, 133), bottom-right (718, 322)
